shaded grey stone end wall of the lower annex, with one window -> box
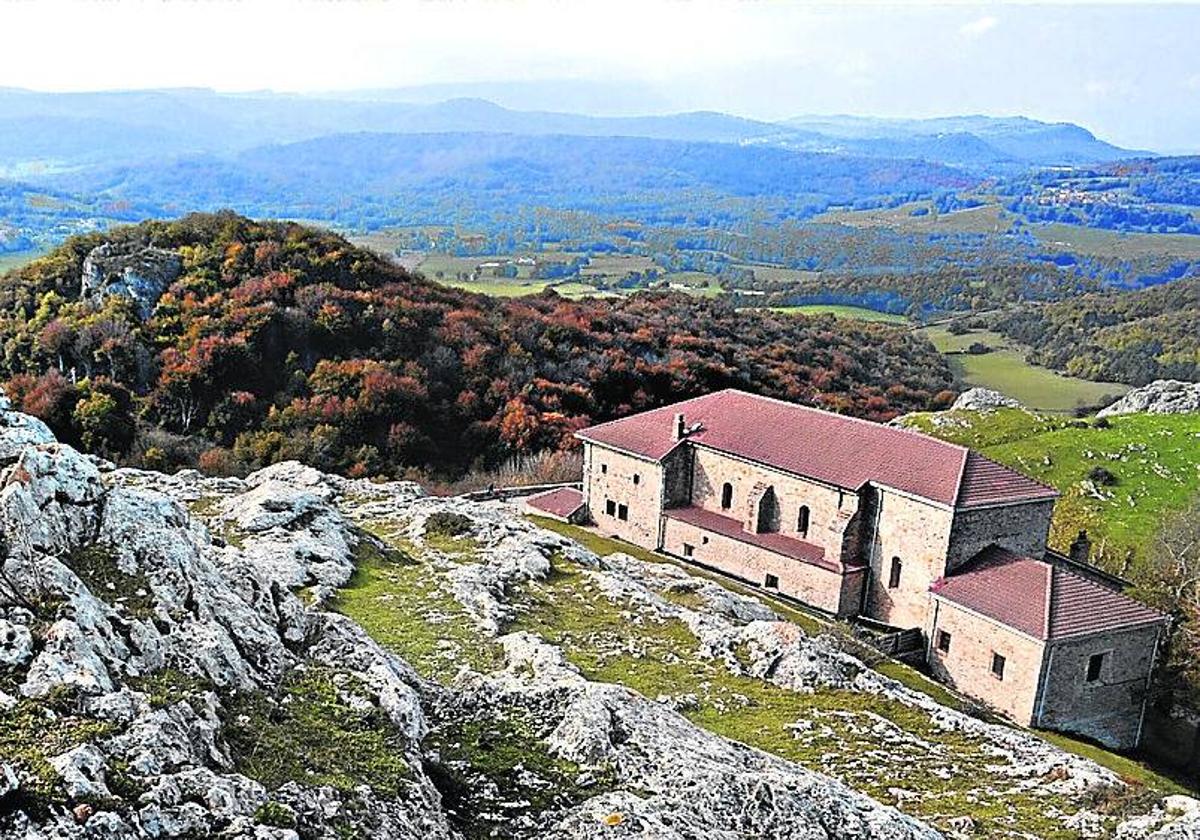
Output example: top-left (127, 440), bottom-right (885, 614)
top-left (1037, 624), bottom-right (1159, 750)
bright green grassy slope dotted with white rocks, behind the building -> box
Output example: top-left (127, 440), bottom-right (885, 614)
top-left (906, 409), bottom-right (1200, 574)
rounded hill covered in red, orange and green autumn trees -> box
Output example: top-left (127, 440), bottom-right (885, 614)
top-left (0, 214), bottom-right (952, 474)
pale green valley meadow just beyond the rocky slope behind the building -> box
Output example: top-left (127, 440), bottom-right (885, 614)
top-left (918, 326), bottom-right (1129, 413)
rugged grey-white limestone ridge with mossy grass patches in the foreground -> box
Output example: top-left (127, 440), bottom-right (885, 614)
top-left (0, 403), bottom-right (1200, 840)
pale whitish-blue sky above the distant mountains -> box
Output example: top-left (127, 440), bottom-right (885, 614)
top-left (0, 0), bottom-right (1200, 151)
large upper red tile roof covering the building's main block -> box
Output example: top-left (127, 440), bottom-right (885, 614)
top-left (578, 389), bottom-right (1057, 506)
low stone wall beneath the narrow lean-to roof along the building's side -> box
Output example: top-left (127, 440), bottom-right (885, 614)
top-left (662, 518), bottom-right (863, 618)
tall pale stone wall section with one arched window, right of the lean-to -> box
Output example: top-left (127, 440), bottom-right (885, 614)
top-left (863, 487), bottom-right (953, 628)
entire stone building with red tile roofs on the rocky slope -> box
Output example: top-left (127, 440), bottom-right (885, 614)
top-left (530, 390), bottom-right (1166, 749)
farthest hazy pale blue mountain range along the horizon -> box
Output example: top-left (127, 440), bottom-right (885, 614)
top-left (0, 89), bottom-right (1146, 175)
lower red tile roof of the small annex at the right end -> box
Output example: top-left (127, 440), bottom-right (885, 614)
top-left (930, 546), bottom-right (1165, 641)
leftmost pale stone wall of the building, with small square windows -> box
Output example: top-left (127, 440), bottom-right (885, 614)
top-left (583, 443), bottom-right (664, 550)
